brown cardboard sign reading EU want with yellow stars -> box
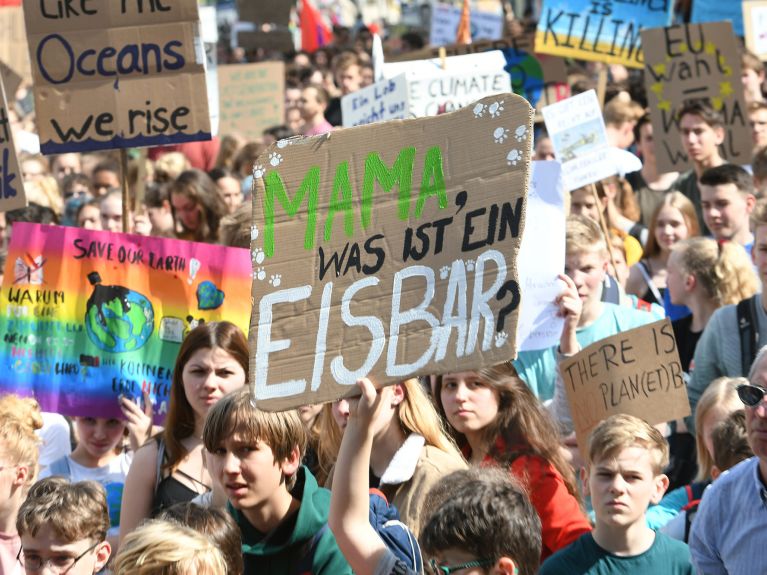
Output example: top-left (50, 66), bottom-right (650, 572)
top-left (642, 22), bottom-right (753, 172)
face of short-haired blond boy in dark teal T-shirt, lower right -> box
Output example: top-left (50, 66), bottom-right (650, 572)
top-left (588, 445), bottom-right (668, 527)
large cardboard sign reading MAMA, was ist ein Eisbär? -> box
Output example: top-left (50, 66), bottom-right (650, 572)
top-left (250, 94), bottom-right (533, 410)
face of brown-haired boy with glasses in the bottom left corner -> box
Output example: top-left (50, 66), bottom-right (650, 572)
top-left (21, 525), bottom-right (111, 575)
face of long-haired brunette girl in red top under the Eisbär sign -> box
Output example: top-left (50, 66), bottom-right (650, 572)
top-left (440, 371), bottom-right (499, 443)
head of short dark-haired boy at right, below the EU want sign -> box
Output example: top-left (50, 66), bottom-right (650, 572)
top-left (699, 164), bottom-right (756, 254)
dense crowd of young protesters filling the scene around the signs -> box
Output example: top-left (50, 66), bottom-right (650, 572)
top-left (0, 4), bottom-right (767, 575)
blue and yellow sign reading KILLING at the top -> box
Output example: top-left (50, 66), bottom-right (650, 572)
top-left (535, 0), bottom-right (672, 68)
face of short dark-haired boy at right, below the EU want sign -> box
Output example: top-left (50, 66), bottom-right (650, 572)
top-left (700, 184), bottom-right (754, 240)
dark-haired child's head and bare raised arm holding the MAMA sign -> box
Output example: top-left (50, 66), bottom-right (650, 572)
top-left (329, 379), bottom-right (541, 575)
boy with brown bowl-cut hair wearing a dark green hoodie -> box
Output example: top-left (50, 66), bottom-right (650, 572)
top-left (202, 388), bottom-right (351, 575)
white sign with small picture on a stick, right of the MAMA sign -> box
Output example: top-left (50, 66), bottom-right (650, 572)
top-left (543, 90), bottom-right (615, 191)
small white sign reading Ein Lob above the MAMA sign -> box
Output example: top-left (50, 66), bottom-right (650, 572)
top-left (341, 74), bottom-right (410, 127)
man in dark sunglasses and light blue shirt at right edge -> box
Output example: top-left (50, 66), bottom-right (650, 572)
top-left (690, 347), bottom-right (767, 575)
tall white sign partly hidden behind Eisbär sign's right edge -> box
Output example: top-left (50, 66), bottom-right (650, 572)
top-left (517, 162), bottom-right (565, 351)
